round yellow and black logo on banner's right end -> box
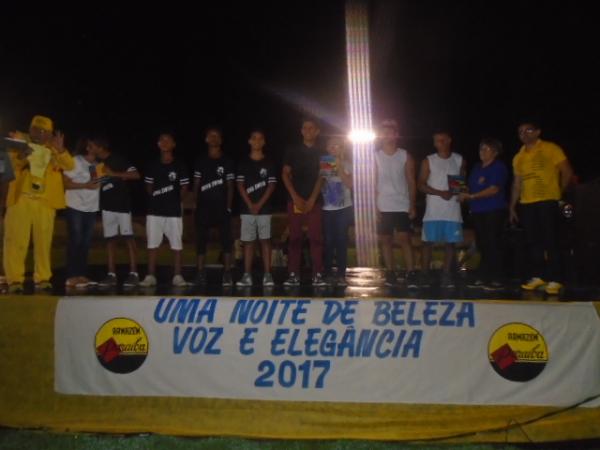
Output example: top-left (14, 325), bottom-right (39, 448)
top-left (488, 323), bottom-right (549, 381)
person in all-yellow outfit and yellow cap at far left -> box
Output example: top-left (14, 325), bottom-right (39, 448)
top-left (3, 116), bottom-right (74, 293)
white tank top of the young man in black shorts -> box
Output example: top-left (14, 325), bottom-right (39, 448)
top-left (375, 148), bottom-right (410, 212)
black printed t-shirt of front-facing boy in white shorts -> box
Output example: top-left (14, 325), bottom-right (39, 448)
top-left (144, 160), bottom-right (190, 217)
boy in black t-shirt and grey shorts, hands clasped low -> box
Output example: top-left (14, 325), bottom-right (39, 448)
top-left (236, 130), bottom-right (277, 287)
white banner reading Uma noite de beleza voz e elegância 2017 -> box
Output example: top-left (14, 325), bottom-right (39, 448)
top-left (55, 297), bottom-right (600, 406)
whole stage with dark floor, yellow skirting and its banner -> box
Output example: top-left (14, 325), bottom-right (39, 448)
top-left (0, 266), bottom-right (600, 443)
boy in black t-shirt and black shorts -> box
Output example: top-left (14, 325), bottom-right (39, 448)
top-left (194, 128), bottom-right (235, 286)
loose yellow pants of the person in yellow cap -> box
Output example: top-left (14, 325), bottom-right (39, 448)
top-left (3, 195), bottom-right (56, 283)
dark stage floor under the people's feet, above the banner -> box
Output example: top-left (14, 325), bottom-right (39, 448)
top-left (5, 265), bottom-right (600, 301)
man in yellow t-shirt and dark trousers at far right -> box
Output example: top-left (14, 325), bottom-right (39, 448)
top-left (510, 121), bottom-right (573, 294)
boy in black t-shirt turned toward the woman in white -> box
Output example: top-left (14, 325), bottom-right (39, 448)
top-left (90, 138), bottom-right (140, 287)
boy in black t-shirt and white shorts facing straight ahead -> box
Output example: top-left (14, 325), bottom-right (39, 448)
top-left (140, 133), bottom-right (190, 287)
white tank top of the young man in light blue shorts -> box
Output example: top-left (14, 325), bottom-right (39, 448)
top-left (423, 153), bottom-right (462, 222)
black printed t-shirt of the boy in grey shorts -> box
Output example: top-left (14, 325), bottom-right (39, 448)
top-left (236, 157), bottom-right (277, 214)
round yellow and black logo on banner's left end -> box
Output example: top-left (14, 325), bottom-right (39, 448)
top-left (96, 318), bottom-right (148, 373)
